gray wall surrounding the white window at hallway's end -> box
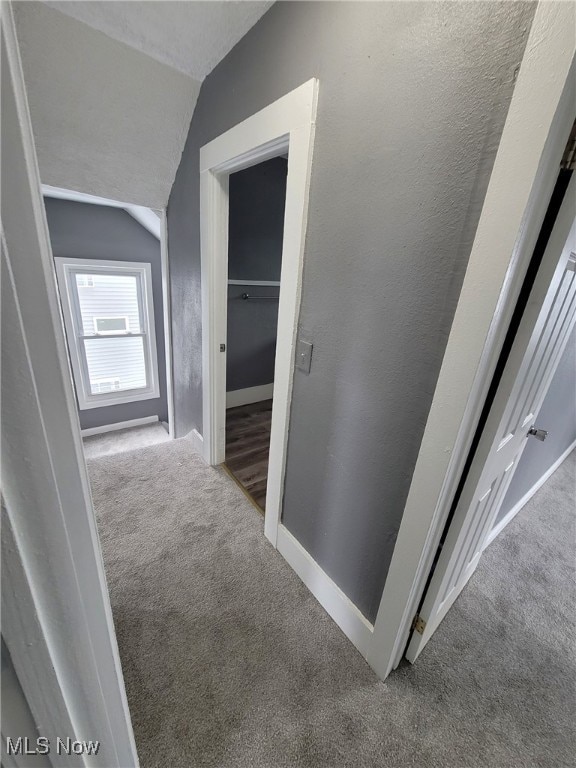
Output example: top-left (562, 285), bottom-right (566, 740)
top-left (44, 198), bottom-right (168, 429)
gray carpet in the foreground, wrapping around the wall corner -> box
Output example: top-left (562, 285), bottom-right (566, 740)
top-left (88, 440), bottom-right (576, 768)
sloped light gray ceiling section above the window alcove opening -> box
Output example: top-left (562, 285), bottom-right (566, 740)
top-left (15, 2), bottom-right (200, 208)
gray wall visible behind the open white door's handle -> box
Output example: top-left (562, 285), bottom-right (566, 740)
top-left (495, 328), bottom-right (576, 525)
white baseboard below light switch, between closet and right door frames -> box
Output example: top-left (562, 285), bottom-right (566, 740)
top-left (277, 524), bottom-right (374, 657)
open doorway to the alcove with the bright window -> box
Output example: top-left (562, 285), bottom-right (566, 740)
top-left (43, 186), bottom-right (172, 458)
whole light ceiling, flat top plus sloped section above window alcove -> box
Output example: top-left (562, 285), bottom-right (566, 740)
top-left (14, 2), bottom-right (270, 208)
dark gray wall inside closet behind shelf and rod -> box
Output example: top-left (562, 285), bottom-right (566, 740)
top-left (226, 157), bottom-right (288, 391)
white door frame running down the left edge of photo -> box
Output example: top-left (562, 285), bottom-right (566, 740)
top-left (1, 3), bottom-right (138, 768)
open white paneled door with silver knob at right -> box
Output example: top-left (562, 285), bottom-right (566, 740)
top-left (406, 176), bottom-right (576, 662)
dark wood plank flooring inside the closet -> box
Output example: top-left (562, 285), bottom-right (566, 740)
top-left (226, 400), bottom-right (272, 511)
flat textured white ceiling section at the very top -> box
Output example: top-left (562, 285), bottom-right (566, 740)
top-left (46, 0), bottom-right (273, 80)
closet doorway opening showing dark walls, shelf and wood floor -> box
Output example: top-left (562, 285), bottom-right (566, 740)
top-left (225, 156), bottom-right (288, 512)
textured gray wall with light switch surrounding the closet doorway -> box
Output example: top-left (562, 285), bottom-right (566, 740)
top-left (168, 2), bottom-right (534, 619)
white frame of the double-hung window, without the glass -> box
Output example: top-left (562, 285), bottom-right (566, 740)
top-left (54, 257), bottom-right (160, 411)
